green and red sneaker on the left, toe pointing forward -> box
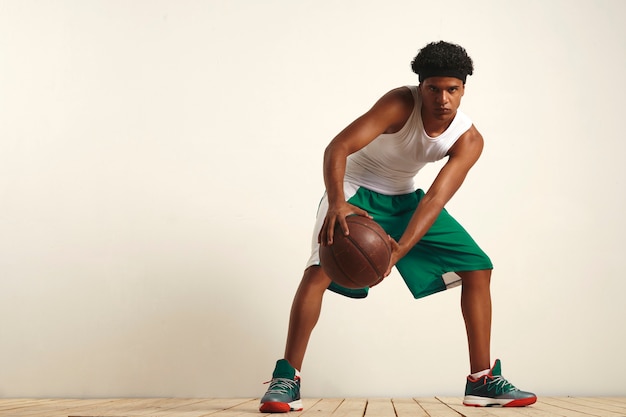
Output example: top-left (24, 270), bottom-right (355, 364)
top-left (259, 359), bottom-right (302, 413)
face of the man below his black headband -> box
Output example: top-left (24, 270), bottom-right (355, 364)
top-left (419, 77), bottom-right (465, 120)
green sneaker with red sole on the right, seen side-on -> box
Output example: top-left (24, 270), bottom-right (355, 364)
top-left (463, 359), bottom-right (537, 407)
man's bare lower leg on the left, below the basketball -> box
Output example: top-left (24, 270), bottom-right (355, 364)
top-left (285, 266), bottom-right (330, 370)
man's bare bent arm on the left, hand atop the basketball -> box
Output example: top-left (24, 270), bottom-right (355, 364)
top-left (319, 88), bottom-right (414, 245)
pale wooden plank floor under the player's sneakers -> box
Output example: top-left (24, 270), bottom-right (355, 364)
top-left (0, 397), bottom-right (626, 417)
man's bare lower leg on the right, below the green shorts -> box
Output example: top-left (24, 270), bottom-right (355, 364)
top-left (457, 270), bottom-right (491, 373)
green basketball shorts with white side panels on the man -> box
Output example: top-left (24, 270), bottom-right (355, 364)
top-left (309, 183), bottom-right (493, 298)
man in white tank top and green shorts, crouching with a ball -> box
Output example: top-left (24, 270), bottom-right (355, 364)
top-left (260, 41), bottom-right (536, 412)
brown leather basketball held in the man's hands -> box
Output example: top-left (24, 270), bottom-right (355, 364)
top-left (320, 215), bottom-right (391, 289)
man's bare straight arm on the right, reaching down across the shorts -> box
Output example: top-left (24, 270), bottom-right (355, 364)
top-left (385, 126), bottom-right (483, 275)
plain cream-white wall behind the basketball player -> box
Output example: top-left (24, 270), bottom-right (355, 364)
top-left (0, 0), bottom-right (626, 397)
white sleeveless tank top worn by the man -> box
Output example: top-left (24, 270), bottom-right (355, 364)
top-left (345, 86), bottom-right (472, 195)
